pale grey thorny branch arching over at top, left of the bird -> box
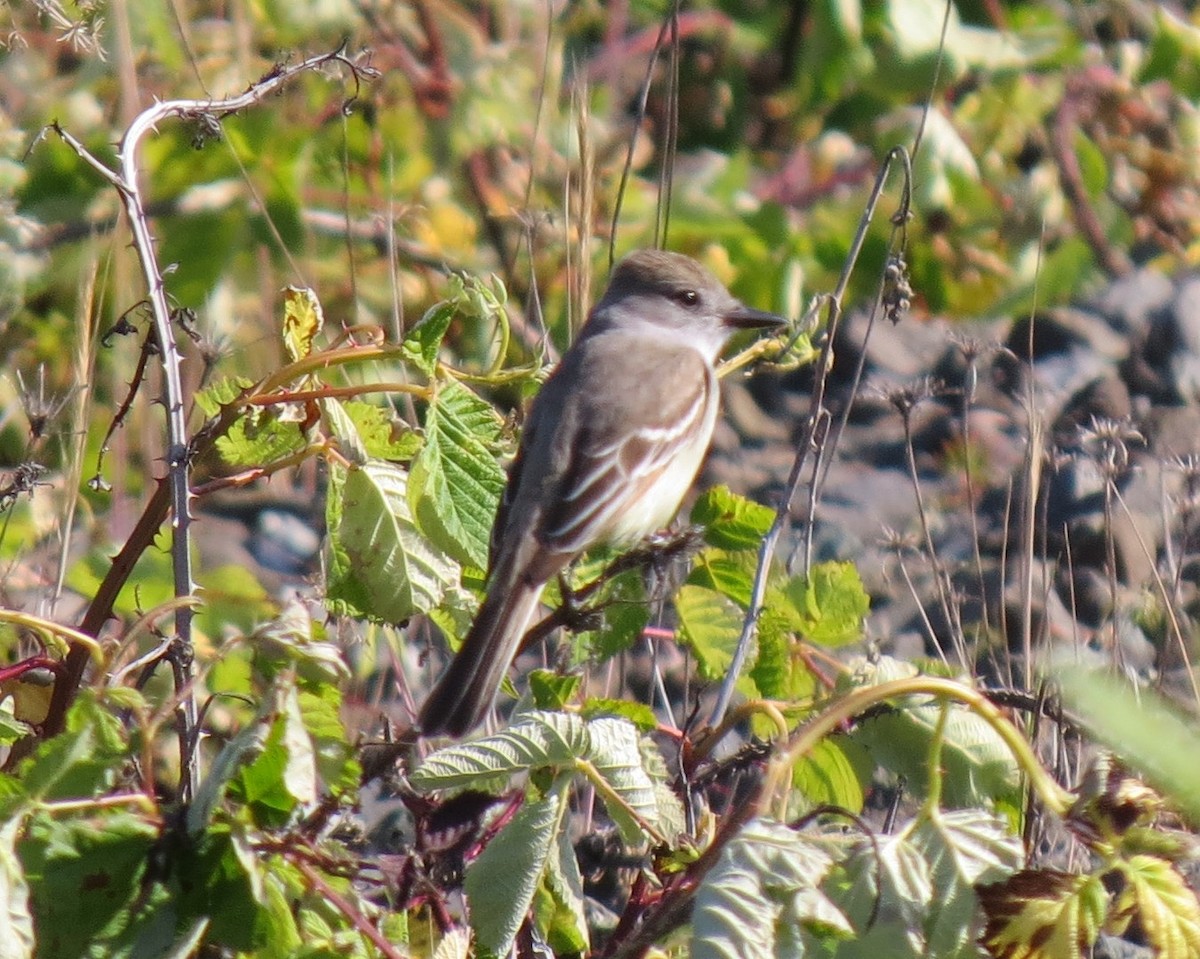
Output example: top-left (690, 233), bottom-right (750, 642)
top-left (46, 47), bottom-right (378, 802)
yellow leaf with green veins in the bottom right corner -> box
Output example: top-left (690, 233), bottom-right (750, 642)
top-left (1110, 856), bottom-right (1200, 959)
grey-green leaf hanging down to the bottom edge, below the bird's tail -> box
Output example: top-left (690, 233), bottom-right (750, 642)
top-left (464, 789), bottom-right (569, 955)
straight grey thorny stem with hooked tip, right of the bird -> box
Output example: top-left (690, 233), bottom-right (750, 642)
top-left (708, 146), bottom-right (912, 726)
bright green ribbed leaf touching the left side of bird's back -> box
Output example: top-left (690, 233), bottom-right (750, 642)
top-left (408, 383), bottom-right (504, 569)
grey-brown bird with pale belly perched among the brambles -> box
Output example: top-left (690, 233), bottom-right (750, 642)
top-left (418, 250), bottom-right (787, 738)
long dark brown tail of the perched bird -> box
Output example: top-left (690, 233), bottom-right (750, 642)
top-left (420, 579), bottom-right (544, 737)
